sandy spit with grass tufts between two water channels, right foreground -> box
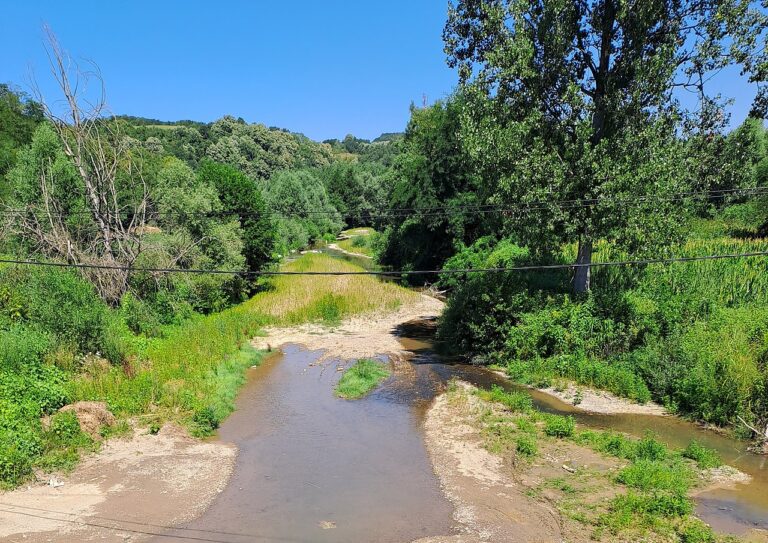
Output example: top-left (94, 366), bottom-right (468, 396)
top-left (419, 382), bottom-right (768, 543)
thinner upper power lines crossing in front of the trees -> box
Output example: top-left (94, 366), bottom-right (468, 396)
top-left (0, 187), bottom-right (768, 219)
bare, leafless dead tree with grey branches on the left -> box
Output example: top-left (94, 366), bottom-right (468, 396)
top-left (20, 27), bottom-right (148, 304)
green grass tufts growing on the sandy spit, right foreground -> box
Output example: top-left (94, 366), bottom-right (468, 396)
top-left (460, 387), bottom-right (736, 543)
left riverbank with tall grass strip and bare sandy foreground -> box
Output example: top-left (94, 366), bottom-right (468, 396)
top-left (0, 254), bottom-right (426, 541)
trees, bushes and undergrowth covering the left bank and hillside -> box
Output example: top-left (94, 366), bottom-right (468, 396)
top-left (0, 81), bottom-right (404, 486)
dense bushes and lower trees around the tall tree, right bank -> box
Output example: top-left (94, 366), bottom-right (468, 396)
top-left (379, 91), bottom-right (768, 440)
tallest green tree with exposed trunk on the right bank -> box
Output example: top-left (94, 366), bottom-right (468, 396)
top-left (444, 0), bottom-right (766, 293)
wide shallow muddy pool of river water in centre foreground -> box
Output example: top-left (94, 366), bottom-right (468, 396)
top-left (162, 346), bottom-right (453, 543)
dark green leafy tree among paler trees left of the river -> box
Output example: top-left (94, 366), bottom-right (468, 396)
top-left (197, 160), bottom-right (275, 271)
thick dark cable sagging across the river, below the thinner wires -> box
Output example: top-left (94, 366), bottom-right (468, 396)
top-left (0, 251), bottom-right (768, 277)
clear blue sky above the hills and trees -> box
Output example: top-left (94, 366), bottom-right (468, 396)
top-left (0, 0), bottom-right (754, 140)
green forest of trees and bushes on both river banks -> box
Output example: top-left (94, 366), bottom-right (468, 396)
top-left (0, 0), bottom-right (768, 512)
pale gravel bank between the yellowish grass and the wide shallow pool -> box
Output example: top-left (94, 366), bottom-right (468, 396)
top-left (252, 294), bottom-right (444, 360)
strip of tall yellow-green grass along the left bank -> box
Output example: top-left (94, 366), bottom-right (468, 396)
top-left (69, 254), bottom-right (418, 433)
